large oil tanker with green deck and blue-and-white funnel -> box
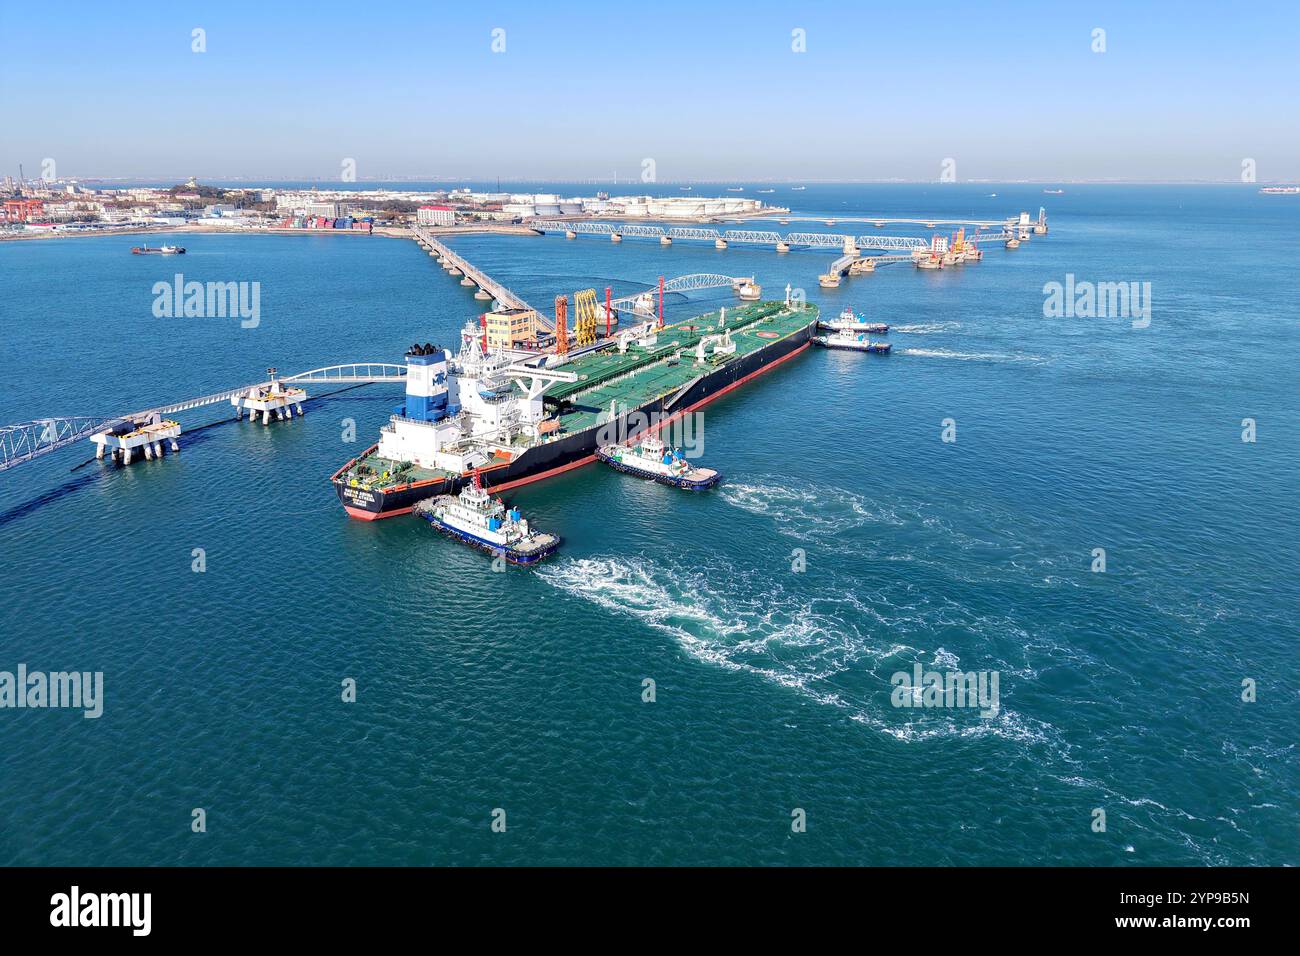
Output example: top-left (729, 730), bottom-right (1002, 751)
top-left (332, 298), bottom-right (818, 520)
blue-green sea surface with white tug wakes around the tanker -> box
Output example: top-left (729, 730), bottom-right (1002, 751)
top-left (0, 183), bottom-right (1300, 865)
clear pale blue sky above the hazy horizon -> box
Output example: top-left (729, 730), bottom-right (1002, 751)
top-left (0, 0), bottom-right (1300, 181)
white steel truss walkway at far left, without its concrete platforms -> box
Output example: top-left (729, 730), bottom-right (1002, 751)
top-left (0, 362), bottom-right (406, 471)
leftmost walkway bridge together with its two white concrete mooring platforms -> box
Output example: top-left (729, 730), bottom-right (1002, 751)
top-left (0, 362), bottom-right (407, 471)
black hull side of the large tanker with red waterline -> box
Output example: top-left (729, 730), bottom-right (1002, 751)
top-left (333, 321), bottom-right (816, 520)
